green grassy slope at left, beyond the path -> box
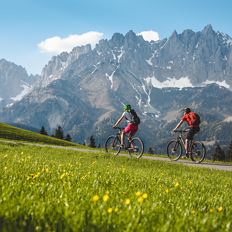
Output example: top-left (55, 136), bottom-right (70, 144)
top-left (0, 123), bottom-right (80, 146)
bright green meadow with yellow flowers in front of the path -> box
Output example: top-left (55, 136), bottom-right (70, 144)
top-left (0, 144), bottom-right (232, 232)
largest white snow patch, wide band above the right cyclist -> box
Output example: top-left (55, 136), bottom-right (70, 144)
top-left (145, 76), bottom-right (193, 89)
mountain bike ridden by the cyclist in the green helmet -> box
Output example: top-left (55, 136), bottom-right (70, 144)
top-left (105, 127), bottom-right (144, 158)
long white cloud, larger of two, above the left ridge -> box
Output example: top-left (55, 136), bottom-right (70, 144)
top-left (38, 31), bottom-right (103, 54)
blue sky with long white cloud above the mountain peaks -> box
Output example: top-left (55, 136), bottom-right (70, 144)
top-left (0, 0), bottom-right (232, 74)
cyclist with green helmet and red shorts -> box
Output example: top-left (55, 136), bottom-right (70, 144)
top-left (113, 104), bottom-right (138, 147)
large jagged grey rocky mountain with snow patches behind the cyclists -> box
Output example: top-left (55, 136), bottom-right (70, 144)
top-left (0, 25), bottom-right (232, 150)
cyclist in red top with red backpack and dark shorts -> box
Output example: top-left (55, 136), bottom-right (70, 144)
top-left (173, 108), bottom-right (200, 156)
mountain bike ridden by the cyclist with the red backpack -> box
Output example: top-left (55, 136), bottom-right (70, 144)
top-left (167, 129), bottom-right (206, 163)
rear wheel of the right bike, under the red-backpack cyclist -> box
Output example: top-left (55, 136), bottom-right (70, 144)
top-left (190, 141), bottom-right (206, 163)
